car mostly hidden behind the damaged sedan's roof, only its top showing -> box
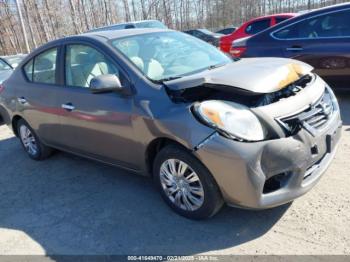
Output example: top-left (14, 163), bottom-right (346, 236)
top-left (88, 20), bottom-right (167, 32)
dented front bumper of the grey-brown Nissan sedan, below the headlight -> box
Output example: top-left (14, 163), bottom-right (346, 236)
top-left (195, 92), bottom-right (342, 209)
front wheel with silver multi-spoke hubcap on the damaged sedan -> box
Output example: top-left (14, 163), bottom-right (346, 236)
top-left (153, 145), bottom-right (224, 220)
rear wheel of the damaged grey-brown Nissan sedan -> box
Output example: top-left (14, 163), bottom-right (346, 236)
top-left (17, 119), bottom-right (53, 160)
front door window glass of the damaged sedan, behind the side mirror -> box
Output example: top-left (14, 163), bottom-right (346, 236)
top-left (65, 44), bottom-right (122, 88)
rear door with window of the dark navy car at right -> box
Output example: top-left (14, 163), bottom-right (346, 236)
top-left (273, 10), bottom-right (350, 86)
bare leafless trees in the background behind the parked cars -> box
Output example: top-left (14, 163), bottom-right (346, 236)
top-left (0, 0), bottom-right (346, 55)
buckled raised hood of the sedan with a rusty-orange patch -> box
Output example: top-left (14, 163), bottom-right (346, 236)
top-left (165, 58), bottom-right (313, 94)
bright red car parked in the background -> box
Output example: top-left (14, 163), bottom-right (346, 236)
top-left (220, 13), bottom-right (297, 53)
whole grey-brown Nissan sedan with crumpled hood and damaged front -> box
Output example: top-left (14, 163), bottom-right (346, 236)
top-left (0, 29), bottom-right (341, 219)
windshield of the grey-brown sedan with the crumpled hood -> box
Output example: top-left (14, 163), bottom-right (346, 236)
top-left (111, 32), bottom-right (232, 81)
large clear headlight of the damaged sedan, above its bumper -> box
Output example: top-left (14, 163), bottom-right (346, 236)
top-left (194, 100), bottom-right (265, 141)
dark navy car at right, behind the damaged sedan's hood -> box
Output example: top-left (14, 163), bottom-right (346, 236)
top-left (231, 3), bottom-right (350, 88)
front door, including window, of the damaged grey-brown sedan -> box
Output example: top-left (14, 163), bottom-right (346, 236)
top-left (54, 43), bottom-right (138, 169)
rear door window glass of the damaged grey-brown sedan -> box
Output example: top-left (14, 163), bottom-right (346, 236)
top-left (24, 48), bottom-right (57, 84)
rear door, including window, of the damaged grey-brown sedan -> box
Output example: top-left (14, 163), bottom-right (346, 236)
top-left (16, 46), bottom-right (61, 145)
